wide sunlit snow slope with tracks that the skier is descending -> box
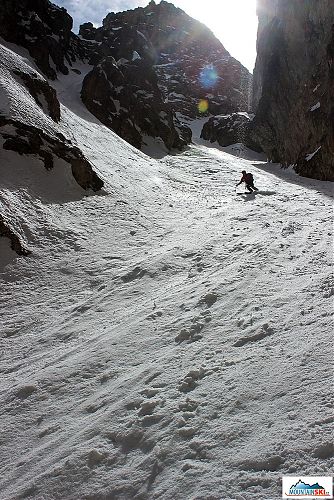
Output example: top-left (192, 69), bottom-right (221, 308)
top-left (0, 56), bottom-right (334, 500)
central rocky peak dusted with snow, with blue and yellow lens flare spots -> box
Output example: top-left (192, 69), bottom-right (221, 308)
top-left (80, 1), bottom-right (251, 149)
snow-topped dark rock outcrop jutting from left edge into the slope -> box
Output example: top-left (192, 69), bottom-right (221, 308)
top-left (0, 45), bottom-right (103, 191)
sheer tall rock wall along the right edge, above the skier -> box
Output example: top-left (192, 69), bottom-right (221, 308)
top-left (253, 0), bottom-right (334, 181)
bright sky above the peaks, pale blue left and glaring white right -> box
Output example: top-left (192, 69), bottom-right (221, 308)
top-left (53, 0), bottom-right (257, 72)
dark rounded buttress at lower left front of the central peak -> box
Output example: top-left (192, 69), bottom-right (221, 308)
top-left (81, 56), bottom-right (187, 149)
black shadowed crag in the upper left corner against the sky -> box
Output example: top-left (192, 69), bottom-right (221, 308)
top-left (0, 0), bottom-right (85, 79)
